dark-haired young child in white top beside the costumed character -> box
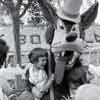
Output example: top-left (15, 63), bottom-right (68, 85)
top-left (26, 48), bottom-right (54, 100)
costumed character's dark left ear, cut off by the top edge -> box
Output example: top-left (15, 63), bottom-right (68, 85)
top-left (37, 0), bottom-right (57, 27)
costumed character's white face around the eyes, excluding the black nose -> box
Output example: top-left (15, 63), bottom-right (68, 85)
top-left (52, 19), bottom-right (79, 47)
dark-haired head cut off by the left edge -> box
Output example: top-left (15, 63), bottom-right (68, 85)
top-left (0, 39), bottom-right (8, 67)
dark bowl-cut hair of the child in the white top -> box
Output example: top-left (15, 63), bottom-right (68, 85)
top-left (28, 48), bottom-right (48, 64)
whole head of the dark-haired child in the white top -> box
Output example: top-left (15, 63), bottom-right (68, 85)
top-left (28, 48), bottom-right (48, 68)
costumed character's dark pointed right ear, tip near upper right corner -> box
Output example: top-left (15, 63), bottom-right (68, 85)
top-left (80, 1), bottom-right (99, 31)
